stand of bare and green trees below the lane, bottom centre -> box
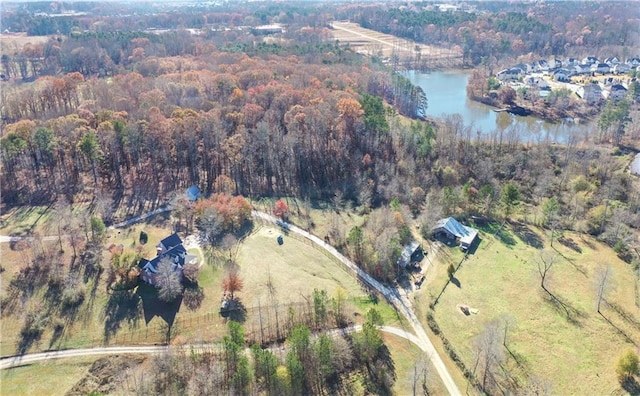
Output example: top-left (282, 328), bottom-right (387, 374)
top-left (135, 309), bottom-right (395, 395)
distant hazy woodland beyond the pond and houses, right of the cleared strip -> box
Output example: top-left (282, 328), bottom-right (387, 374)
top-left (336, 2), bottom-right (640, 65)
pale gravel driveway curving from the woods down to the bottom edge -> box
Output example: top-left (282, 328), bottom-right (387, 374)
top-left (252, 210), bottom-right (461, 396)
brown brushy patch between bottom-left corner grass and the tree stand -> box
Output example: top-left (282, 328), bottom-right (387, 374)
top-left (67, 355), bottom-right (146, 396)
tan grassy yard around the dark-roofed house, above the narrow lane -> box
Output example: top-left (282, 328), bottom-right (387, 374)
top-left (0, 215), bottom-right (225, 355)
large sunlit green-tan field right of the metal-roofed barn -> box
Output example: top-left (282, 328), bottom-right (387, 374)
top-left (422, 226), bottom-right (640, 394)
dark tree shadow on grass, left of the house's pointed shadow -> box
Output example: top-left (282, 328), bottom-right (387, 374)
top-left (104, 289), bottom-right (142, 342)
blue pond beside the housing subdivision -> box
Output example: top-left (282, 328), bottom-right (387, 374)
top-left (404, 71), bottom-right (593, 143)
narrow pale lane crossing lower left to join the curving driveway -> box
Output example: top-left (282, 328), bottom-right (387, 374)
top-left (0, 325), bottom-right (420, 370)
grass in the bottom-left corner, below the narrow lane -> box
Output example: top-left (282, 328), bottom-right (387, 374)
top-left (0, 357), bottom-right (97, 396)
